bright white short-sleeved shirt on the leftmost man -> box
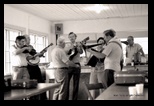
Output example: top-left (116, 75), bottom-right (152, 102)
top-left (11, 45), bottom-right (29, 67)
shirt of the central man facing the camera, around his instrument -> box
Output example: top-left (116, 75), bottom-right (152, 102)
top-left (65, 43), bottom-right (80, 63)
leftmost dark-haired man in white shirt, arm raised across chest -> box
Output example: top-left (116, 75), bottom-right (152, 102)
top-left (11, 36), bottom-right (31, 80)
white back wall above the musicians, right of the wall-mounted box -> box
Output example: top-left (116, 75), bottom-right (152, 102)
top-left (54, 16), bottom-right (148, 38)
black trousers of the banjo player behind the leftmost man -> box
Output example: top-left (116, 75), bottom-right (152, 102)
top-left (27, 65), bottom-right (47, 100)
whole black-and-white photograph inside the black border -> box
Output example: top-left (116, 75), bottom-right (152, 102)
top-left (3, 4), bottom-right (148, 101)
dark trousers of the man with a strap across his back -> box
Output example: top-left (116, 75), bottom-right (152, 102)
top-left (105, 69), bottom-right (114, 87)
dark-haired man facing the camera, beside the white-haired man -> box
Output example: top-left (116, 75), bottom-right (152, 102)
top-left (65, 32), bottom-right (83, 100)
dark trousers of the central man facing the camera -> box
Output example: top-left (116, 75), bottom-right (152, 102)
top-left (68, 63), bottom-right (81, 100)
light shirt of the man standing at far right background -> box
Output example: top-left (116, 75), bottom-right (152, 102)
top-left (126, 43), bottom-right (142, 60)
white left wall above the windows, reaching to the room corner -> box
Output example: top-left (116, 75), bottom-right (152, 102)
top-left (4, 4), bottom-right (56, 60)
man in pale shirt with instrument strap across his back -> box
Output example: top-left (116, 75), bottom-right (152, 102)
top-left (87, 29), bottom-right (123, 87)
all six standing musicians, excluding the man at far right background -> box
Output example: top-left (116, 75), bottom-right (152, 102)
top-left (11, 29), bottom-right (145, 100)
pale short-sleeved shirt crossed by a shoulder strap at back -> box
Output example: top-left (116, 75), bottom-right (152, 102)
top-left (103, 37), bottom-right (123, 71)
